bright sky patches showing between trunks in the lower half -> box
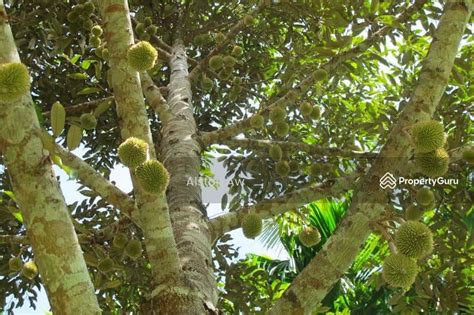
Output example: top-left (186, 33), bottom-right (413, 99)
top-left (11, 146), bottom-right (289, 315)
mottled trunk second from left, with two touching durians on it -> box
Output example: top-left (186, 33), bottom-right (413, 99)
top-left (97, 0), bottom-right (182, 293)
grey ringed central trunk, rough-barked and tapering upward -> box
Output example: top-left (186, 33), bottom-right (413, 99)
top-left (161, 40), bottom-right (217, 314)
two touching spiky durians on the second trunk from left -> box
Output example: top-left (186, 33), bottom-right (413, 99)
top-left (118, 137), bottom-right (169, 193)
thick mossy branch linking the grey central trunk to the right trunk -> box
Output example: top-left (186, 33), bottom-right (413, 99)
top-left (209, 174), bottom-right (357, 241)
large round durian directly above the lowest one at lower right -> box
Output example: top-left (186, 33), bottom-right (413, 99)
top-left (395, 221), bottom-right (433, 258)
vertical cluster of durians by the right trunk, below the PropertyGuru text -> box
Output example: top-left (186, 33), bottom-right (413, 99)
top-left (382, 188), bottom-right (435, 289)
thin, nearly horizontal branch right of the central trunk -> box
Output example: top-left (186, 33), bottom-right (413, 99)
top-left (221, 139), bottom-right (378, 159)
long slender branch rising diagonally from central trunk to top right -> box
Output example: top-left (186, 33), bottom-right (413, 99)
top-left (199, 0), bottom-right (427, 147)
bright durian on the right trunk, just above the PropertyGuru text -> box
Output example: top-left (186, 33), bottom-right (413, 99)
top-left (411, 120), bottom-right (446, 153)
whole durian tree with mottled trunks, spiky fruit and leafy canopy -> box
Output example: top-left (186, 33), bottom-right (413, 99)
top-left (0, 0), bottom-right (474, 314)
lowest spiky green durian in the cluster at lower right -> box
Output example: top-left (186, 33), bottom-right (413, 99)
top-left (382, 254), bottom-right (418, 289)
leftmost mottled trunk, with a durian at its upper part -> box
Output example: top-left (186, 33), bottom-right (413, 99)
top-left (0, 0), bottom-right (100, 314)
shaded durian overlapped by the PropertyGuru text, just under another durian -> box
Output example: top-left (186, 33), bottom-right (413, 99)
top-left (415, 148), bottom-right (449, 177)
